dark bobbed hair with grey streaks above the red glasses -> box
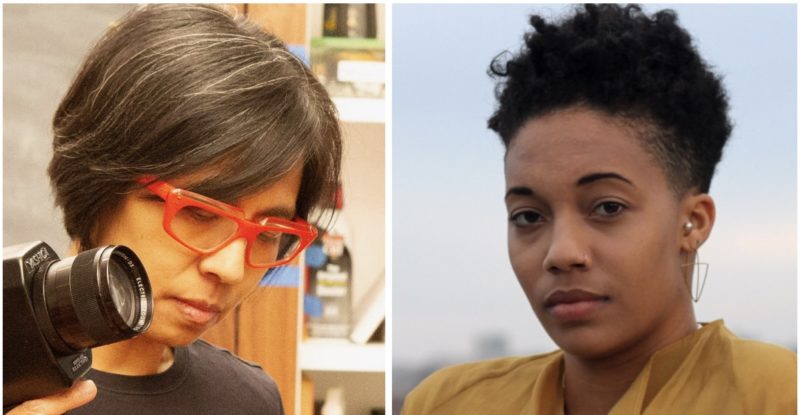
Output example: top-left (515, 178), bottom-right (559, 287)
top-left (48, 5), bottom-right (342, 249)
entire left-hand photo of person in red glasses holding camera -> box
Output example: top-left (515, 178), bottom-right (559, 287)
top-left (3, 4), bottom-right (386, 414)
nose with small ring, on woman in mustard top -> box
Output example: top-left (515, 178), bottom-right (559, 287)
top-left (542, 218), bottom-right (591, 275)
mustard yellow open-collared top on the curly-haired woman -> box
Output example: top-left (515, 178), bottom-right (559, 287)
top-left (403, 320), bottom-right (797, 415)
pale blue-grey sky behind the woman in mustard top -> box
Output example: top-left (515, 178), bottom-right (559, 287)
top-left (392, 4), bottom-right (797, 368)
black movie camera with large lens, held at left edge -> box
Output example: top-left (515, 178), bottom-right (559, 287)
top-left (3, 242), bottom-right (153, 409)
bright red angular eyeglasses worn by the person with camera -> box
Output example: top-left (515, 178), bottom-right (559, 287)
top-left (139, 177), bottom-right (317, 268)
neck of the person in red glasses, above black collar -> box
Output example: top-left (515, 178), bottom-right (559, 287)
top-left (92, 336), bottom-right (175, 376)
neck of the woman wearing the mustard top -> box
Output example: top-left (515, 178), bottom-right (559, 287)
top-left (564, 313), bottom-right (697, 415)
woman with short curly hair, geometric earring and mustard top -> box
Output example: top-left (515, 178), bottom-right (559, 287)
top-left (404, 5), bottom-right (796, 415)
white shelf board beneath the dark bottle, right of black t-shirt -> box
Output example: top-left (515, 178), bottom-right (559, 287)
top-left (298, 339), bottom-right (386, 372)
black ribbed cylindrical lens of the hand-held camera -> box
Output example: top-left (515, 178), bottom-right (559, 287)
top-left (34, 246), bottom-right (153, 353)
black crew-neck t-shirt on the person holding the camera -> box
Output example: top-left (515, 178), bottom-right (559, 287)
top-left (68, 340), bottom-right (283, 415)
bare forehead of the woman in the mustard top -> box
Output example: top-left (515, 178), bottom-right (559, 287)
top-left (505, 108), bottom-right (667, 190)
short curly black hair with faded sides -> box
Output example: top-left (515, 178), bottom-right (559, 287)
top-left (488, 4), bottom-right (732, 195)
